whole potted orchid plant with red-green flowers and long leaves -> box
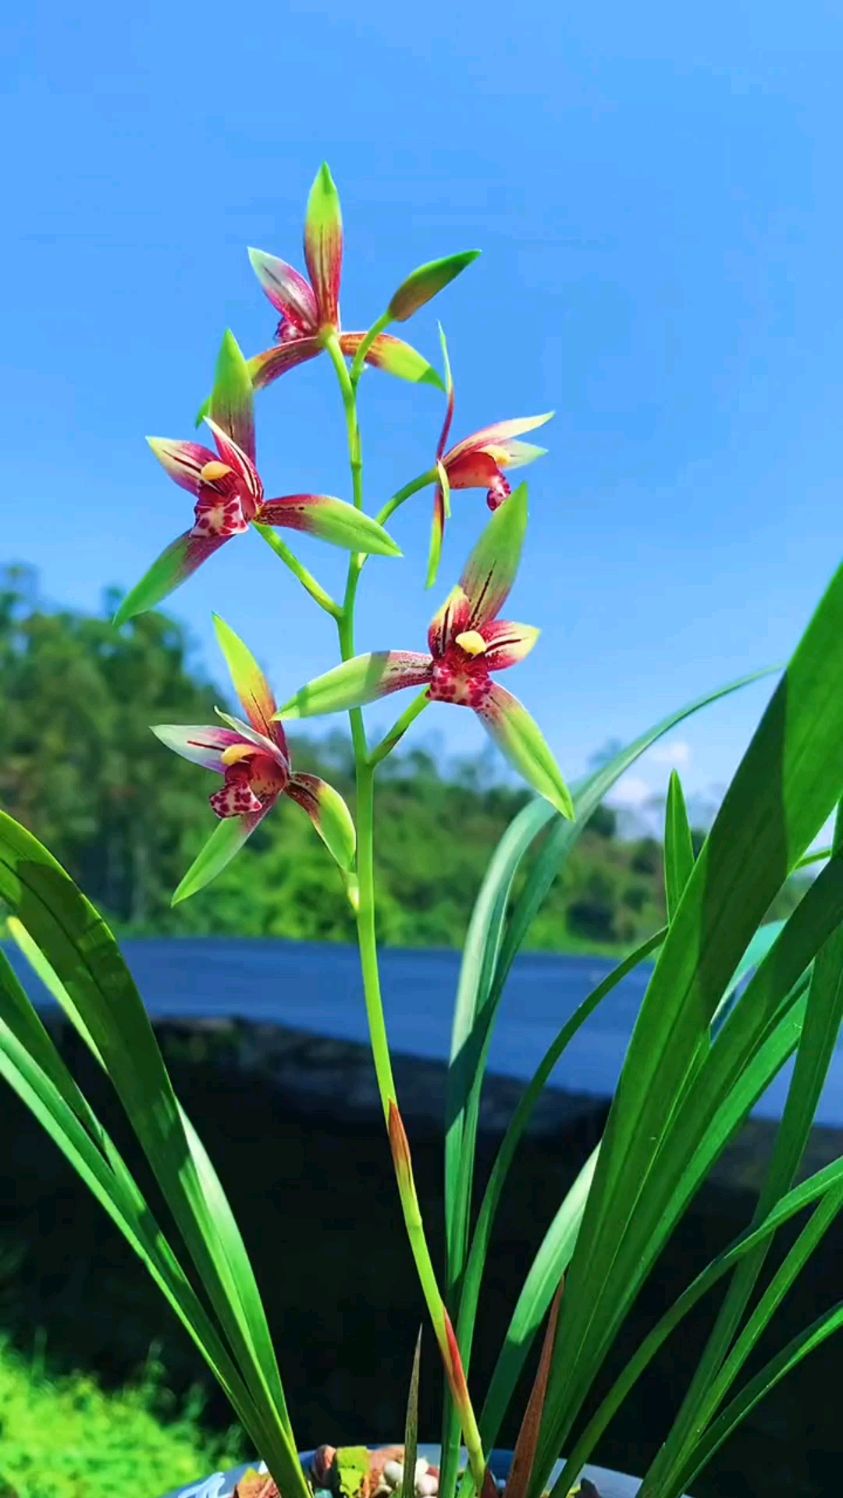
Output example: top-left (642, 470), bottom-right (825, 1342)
top-left (0, 166), bottom-right (843, 1498)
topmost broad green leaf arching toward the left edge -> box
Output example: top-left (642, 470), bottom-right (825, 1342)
top-left (0, 812), bottom-right (305, 1498)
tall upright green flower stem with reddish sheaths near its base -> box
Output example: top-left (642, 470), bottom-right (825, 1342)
top-left (325, 334), bottom-right (485, 1491)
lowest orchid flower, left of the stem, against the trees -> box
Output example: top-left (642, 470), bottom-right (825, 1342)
top-left (153, 614), bottom-right (355, 905)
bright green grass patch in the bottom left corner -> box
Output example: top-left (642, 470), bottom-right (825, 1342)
top-left (0, 1342), bottom-right (243, 1498)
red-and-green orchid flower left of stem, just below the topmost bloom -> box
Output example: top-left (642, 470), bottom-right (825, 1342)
top-left (114, 333), bottom-right (401, 625)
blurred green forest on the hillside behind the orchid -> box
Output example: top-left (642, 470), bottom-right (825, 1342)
top-left (0, 568), bottom-right (795, 951)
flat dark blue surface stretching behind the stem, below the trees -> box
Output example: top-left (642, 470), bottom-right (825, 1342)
top-left (10, 938), bottom-right (843, 1125)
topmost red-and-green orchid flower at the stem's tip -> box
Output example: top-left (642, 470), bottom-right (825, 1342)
top-left (249, 165), bottom-right (442, 389)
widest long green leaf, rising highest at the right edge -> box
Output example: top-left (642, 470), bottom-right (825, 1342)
top-left (539, 568), bottom-right (843, 1479)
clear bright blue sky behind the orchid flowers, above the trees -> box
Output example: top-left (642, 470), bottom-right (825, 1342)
top-left (0, 0), bottom-right (843, 820)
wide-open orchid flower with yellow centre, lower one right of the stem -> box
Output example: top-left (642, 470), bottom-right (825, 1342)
top-left (279, 484), bottom-right (573, 816)
